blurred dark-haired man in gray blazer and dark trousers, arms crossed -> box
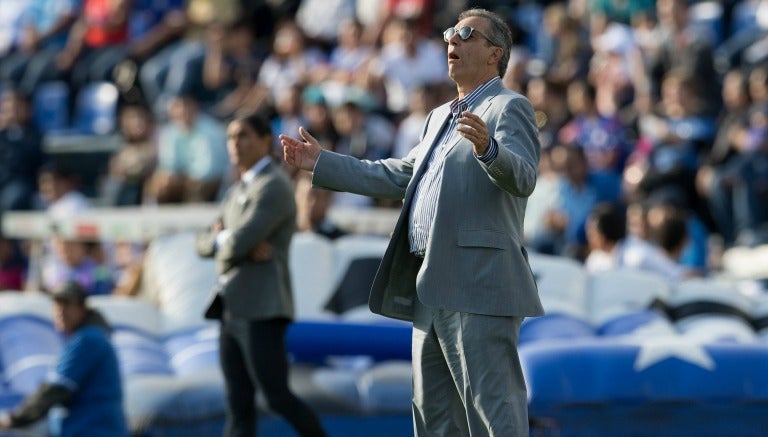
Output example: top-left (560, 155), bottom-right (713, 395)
top-left (197, 116), bottom-right (325, 437)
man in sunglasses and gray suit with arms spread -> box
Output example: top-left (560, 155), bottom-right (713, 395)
top-left (280, 9), bottom-right (543, 436)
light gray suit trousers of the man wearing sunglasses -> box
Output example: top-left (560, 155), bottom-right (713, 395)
top-left (412, 300), bottom-right (528, 437)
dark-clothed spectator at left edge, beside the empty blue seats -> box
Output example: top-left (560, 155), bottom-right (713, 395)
top-left (0, 89), bottom-right (46, 216)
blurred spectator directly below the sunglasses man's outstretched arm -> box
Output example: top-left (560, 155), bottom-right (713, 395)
top-left (294, 173), bottom-right (347, 240)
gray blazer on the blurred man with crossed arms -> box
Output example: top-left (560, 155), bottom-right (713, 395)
top-left (196, 163), bottom-right (296, 319)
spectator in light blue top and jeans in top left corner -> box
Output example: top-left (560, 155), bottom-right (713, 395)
top-left (0, 0), bottom-right (81, 96)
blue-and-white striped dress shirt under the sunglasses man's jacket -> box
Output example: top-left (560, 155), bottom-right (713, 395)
top-left (408, 77), bottom-right (501, 258)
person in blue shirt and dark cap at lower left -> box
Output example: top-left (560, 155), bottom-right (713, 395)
top-left (0, 282), bottom-right (129, 437)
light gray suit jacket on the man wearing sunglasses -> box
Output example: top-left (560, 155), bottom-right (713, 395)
top-left (312, 83), bottom-right (544, 320)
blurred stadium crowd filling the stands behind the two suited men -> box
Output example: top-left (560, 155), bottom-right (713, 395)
top-left (0, 0), bottom-right (768, 294)
